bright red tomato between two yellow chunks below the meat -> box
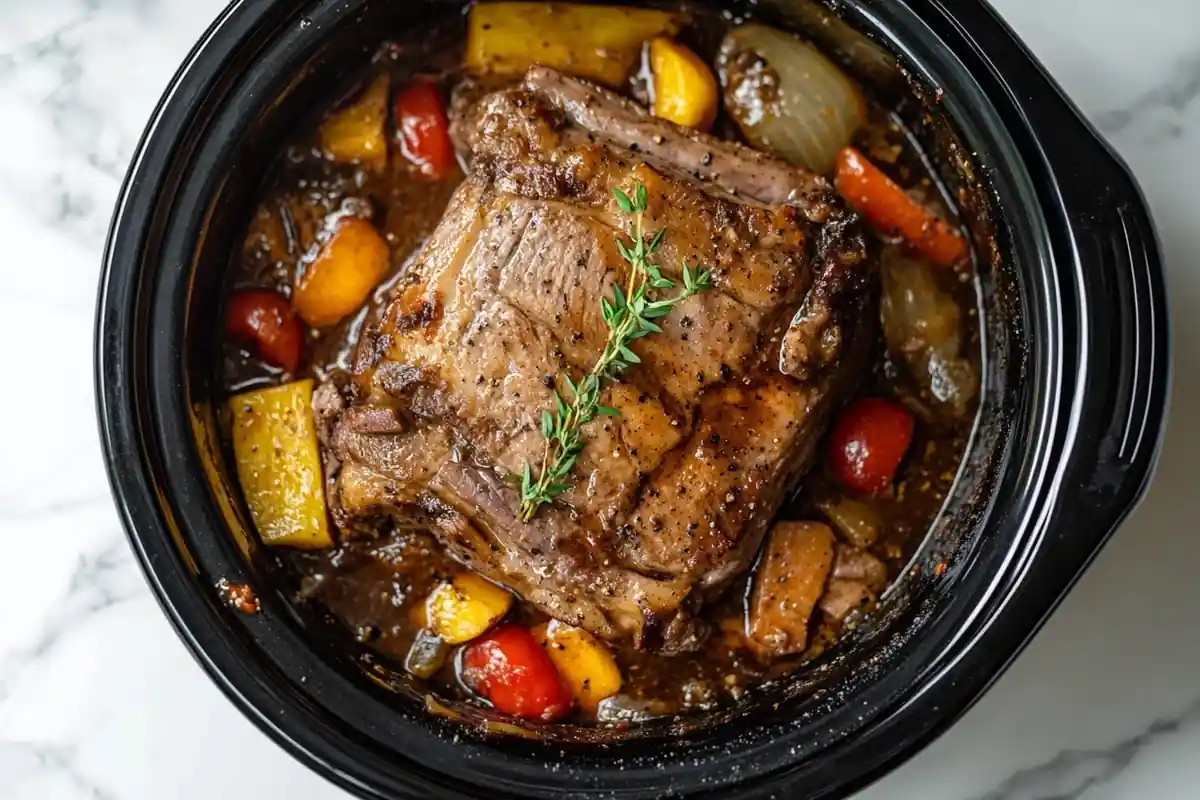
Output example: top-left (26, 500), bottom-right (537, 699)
top-left (462, 625), bottom-right (571, 722)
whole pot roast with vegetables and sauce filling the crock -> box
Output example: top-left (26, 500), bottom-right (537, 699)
top-left (222, 2), bottom-right (979, 726)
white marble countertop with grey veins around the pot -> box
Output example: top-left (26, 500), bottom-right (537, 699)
top-left (0, 0), bottom-right (1200, 800)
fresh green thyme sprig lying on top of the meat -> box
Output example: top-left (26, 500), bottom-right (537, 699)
top-left (521, 184), bottom-right (712, 522)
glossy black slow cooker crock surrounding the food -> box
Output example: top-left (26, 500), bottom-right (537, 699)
top-left (96, 0), bottom-right (1169, 799)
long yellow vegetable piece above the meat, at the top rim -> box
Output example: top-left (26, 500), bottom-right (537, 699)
top-left (467, 2), bottom-right (679, 86)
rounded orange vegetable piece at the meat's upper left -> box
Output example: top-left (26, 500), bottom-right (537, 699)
top-left (292, 217), bottom-right (390, 327)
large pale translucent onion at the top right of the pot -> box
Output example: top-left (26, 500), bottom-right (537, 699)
top-left (718, 24), bottom-right (866, 175)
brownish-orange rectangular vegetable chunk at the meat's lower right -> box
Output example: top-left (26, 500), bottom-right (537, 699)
top-left (750, 522), bottom-right (836, 656)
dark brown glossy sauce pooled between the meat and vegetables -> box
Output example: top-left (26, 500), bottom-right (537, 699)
top-left (222, 10), bottom-right (979, 715)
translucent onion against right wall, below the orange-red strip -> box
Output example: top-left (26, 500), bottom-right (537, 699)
top-left (880, 247), bottom-right (979, 416)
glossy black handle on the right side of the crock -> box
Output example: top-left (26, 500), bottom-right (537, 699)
top-left (1054, 148), bottom-right (1170, 533)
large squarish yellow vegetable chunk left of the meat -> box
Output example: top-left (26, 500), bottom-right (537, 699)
top-left (229, 380), bottom-right (334, 549)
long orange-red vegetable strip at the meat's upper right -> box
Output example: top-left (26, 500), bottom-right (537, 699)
top-left (834, 148), bottom-right (968, 267)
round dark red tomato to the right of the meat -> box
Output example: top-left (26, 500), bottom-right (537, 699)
top-left (829, 397), bottom-right (913, 492)
